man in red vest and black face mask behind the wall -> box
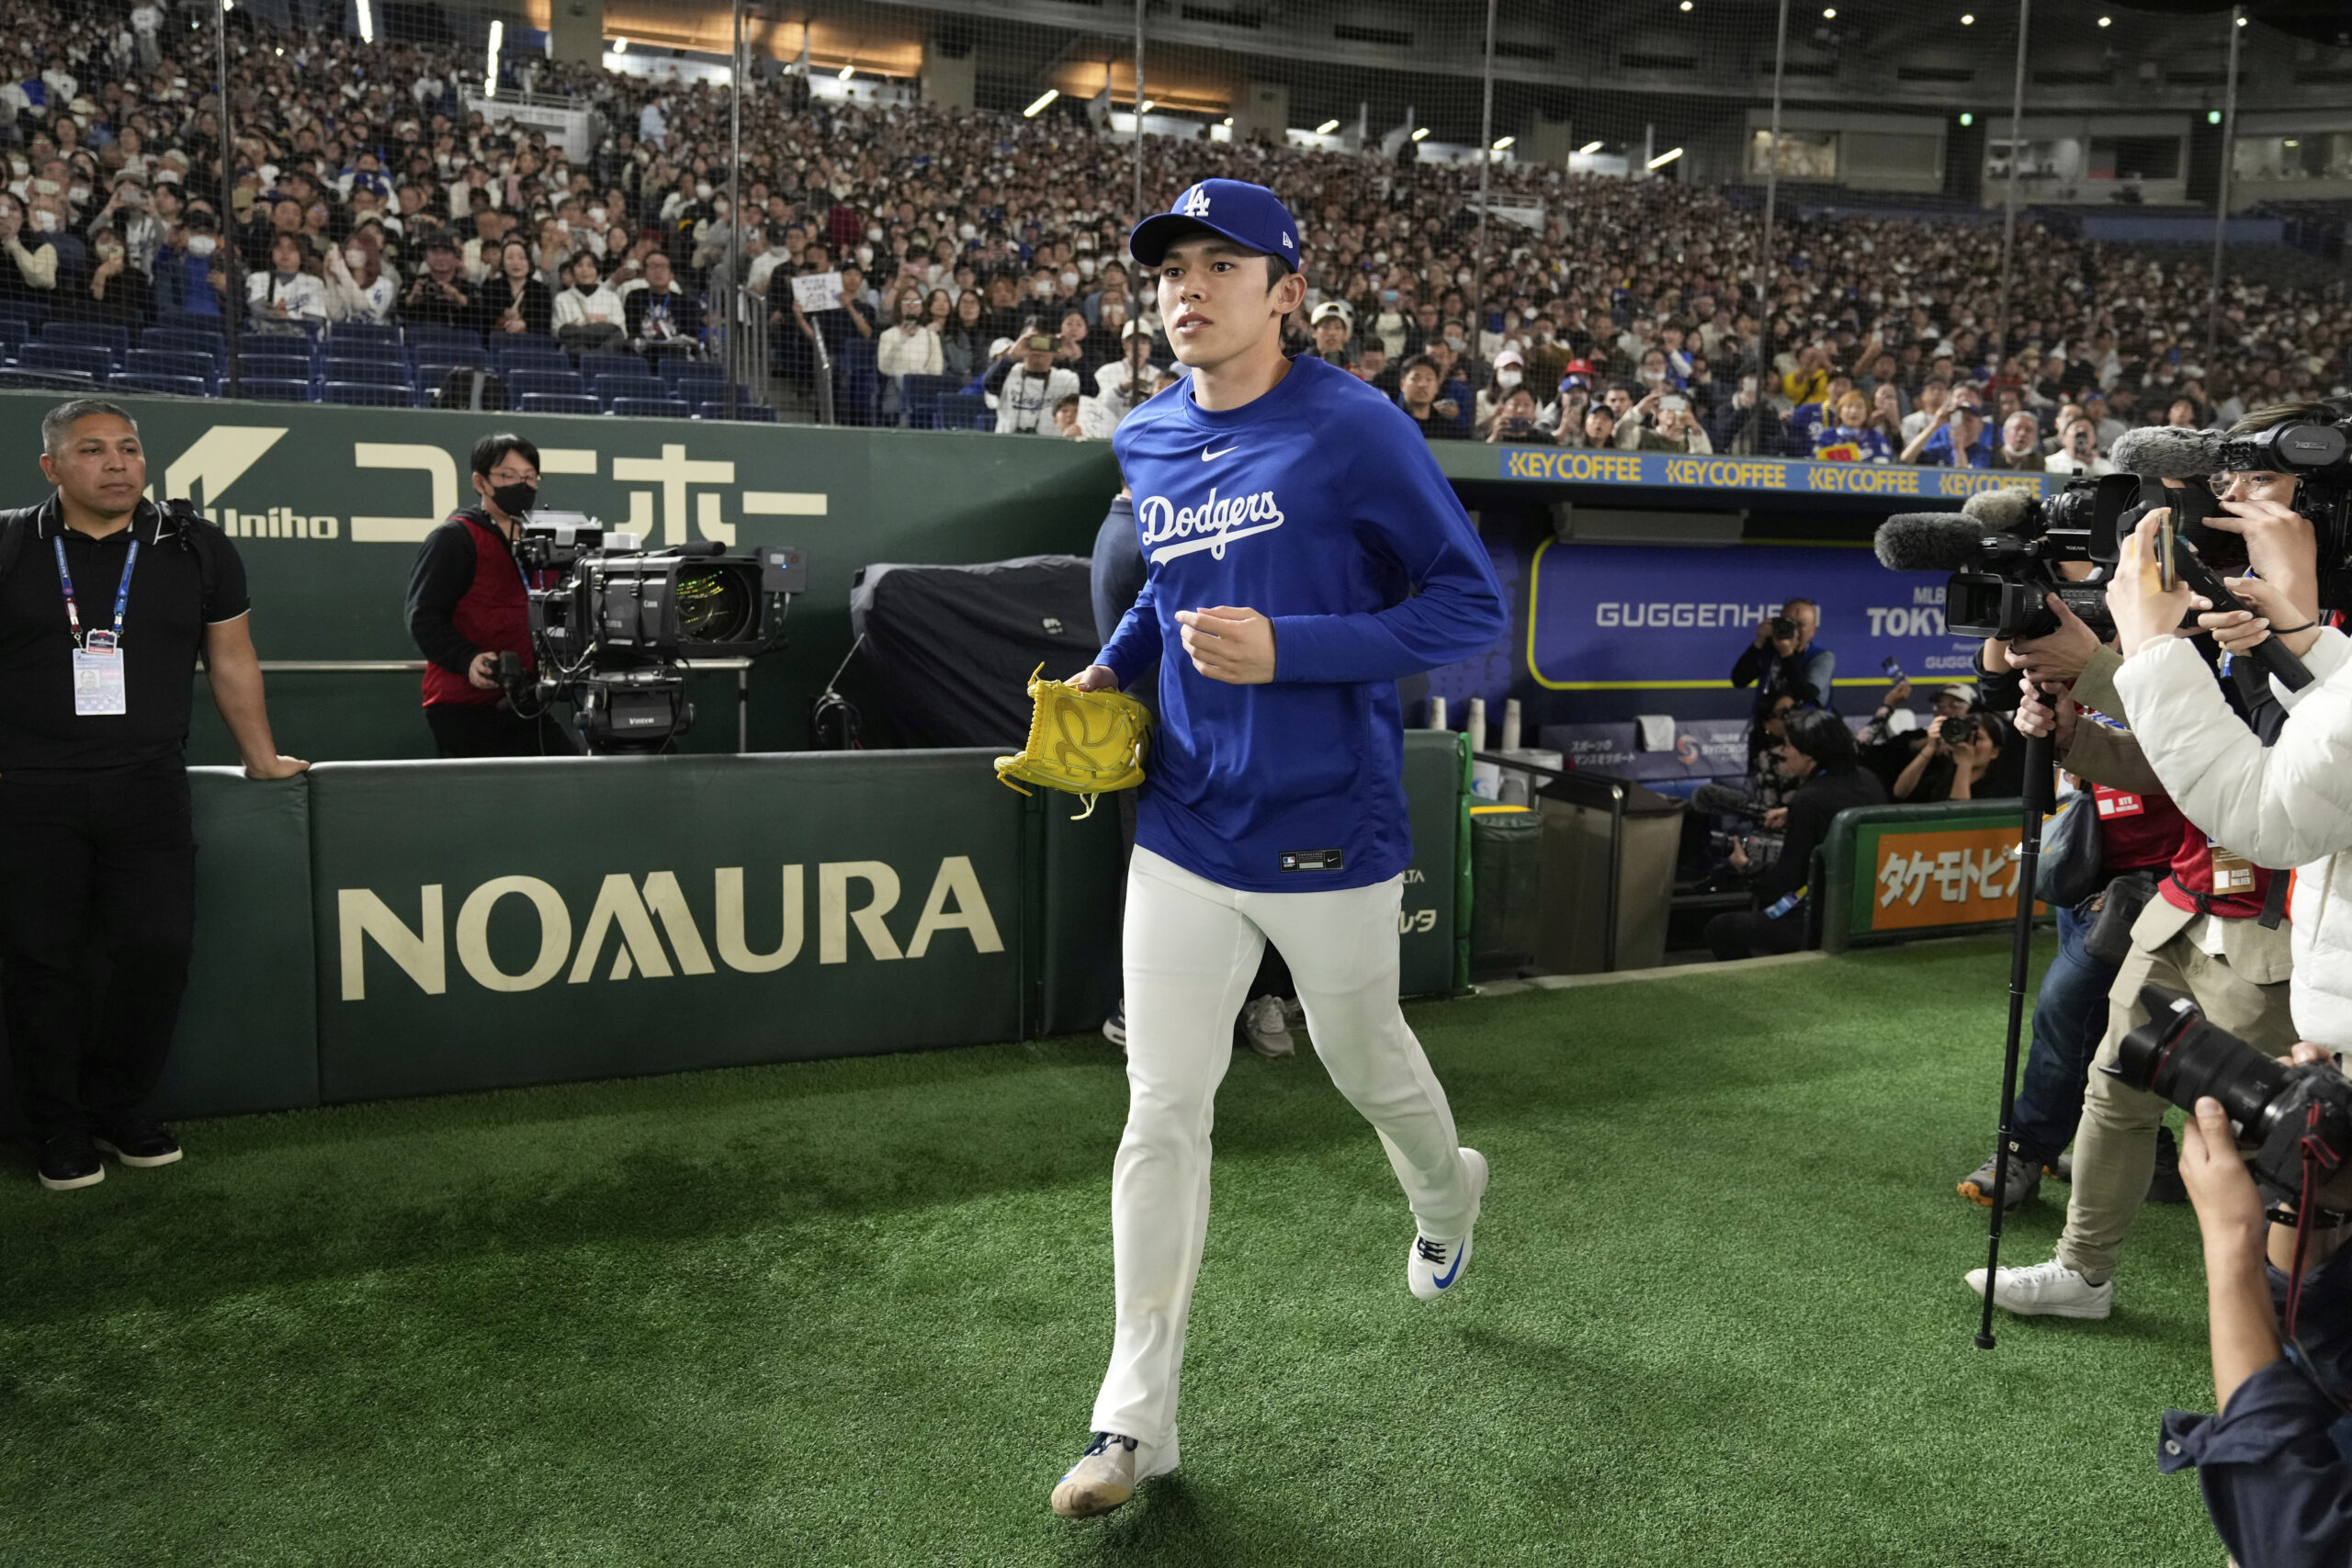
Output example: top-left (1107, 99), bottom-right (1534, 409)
top-left (407, 433), bottom-right (574, 757)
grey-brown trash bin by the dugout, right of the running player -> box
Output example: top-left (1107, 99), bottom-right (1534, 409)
top-left (1536, 769), bottom-right (1689, 976)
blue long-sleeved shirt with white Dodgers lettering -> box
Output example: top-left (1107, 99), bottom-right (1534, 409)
top-left (1096, 357), bottom-right (1510, 894)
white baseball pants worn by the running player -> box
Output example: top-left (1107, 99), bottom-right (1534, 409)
top-left (1093, 846), bottom-right (1477, 1448)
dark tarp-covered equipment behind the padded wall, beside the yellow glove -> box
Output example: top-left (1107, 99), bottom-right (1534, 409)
top-left (849, 555), bottom-right (1101, 750)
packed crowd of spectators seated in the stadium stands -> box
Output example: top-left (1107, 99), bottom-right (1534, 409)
top-left (0, 0), bottom-right (2352, 446)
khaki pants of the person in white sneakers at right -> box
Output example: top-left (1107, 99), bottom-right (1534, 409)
top-left (2058, 933), bottom-right (2296, 1283)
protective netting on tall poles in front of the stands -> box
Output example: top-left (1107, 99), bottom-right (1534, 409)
top-left (0, 0), bottom-right (2352, 449)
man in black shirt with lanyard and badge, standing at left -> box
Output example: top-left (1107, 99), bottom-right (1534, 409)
top-left (0, 398), bottom-right (311, 1192)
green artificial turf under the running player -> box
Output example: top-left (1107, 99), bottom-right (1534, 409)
top-left (0, 941), bottom-right (2222, 1568)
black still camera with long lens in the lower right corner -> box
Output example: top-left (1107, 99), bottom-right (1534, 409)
top-left (2108, 985), bottom-right (2352, 1206)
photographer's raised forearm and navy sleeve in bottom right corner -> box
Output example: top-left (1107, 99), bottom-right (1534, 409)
top-left (2157, 1042), bottom-right (2352, 1568)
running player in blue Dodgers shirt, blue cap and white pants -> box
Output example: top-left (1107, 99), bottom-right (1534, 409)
top-left (1054, 179), bottom-right (1508, 1518)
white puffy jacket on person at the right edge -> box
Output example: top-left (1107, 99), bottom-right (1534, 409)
top-left (2114, 630), bottom-right (2352, 1051)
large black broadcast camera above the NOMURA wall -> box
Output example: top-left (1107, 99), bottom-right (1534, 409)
top-left (501, 510), bottom-right (809, 755)
